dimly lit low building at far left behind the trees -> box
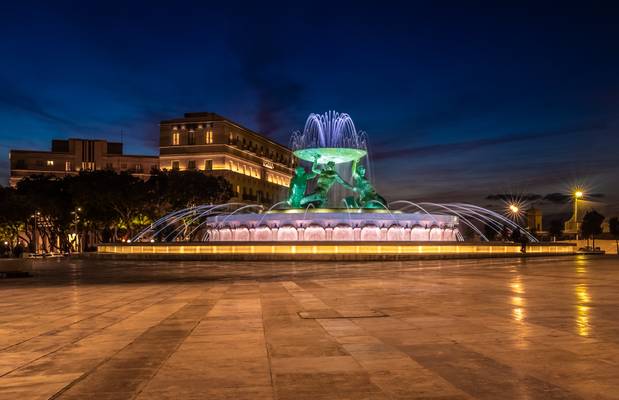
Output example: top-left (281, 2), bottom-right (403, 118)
top-left (9, 139), bottom-right (159, 186)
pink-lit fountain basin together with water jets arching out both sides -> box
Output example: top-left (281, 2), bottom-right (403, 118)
top-left (131, 201), bottom-right (537, 243)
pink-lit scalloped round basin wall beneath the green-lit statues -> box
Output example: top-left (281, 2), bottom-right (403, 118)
top-left (206, 209), bottom-right (459, 242)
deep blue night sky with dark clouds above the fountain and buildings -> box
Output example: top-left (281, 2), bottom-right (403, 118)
top-left (0, 1), bottom-right (619, 213)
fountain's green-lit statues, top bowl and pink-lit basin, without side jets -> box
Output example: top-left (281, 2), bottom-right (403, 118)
top-left (203, 111), bottom-right (458, 241)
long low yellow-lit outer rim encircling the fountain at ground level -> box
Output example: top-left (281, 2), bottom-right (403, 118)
top-left (97, 242), bottom-right (575, 261)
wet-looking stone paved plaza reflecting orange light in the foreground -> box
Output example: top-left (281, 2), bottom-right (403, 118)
top-left (0, 256), bottom-right (619, 400)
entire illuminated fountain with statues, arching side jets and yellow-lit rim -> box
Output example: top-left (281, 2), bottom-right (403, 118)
top-left (102, 111), bottom-right (572, 256)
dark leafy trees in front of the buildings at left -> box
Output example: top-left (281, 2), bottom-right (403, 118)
top-left (0, 171), bottom-right (233, 252)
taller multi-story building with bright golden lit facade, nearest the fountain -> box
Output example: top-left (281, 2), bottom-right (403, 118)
top-left (159, 112), bottom-right (294, 204)
